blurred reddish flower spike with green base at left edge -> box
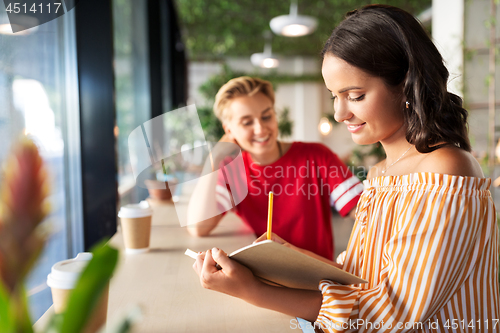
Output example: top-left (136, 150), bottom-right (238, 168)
top-left (0, 138), bottom-right (48, 332)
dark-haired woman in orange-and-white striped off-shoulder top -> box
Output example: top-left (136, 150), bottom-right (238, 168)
top-left (194, 5), bottom-right (500, 332)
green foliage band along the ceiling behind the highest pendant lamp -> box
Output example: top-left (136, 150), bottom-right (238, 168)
top-left (176, 0), bottom-right (432, 60)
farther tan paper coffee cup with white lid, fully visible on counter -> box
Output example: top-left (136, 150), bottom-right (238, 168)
top-left (118, 201), bottom-right (153, 254)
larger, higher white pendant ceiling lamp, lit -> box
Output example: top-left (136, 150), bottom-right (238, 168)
top-left (269, 0), bottom-right (318, 37)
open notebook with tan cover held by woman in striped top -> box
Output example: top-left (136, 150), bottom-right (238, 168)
top-left (186, 240), bottom-right (368, 290)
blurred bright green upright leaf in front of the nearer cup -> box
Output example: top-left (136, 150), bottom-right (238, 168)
top-left (59, 242), bottom-right (118, 333)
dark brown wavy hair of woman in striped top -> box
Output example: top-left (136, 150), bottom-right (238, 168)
top-left (322, 5), bottom-right (471, 153)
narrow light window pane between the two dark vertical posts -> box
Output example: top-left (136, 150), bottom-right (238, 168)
top-left (113, 0), bottom-right (151, 204)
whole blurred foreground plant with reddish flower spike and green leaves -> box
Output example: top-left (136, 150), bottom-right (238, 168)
top-left (0, 138), bottom-right (137, 333)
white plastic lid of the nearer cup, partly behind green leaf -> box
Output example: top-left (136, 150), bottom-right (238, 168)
top-left (47, 252), bottom-right (92, 289)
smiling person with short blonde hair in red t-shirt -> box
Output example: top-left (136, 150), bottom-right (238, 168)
top-left (188, 77), bottom-right (363, 260)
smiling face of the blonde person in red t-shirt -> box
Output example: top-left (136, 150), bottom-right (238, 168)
top-left (223, 92), bottom-right (279, 164)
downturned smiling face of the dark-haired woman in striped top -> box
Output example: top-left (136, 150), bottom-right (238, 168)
top-left (322, 54), bottom-right (406, 145)
